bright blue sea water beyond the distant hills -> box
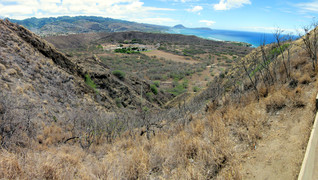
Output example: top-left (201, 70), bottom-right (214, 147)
top-left (168, 28), bottom-right (275, 47)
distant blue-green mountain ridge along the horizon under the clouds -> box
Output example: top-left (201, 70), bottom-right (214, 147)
top-left (9, 16), bottom-right (168, 35)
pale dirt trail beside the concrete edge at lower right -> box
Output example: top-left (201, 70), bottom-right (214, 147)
top-left (241, 87), bottom-right (315, 180)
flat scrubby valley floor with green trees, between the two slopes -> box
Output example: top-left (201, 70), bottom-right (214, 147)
top-left (45, 32), bottom-right (251, 96)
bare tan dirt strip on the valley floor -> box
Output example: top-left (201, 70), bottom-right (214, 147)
top-left (142, 50), bottom-right (200, 64)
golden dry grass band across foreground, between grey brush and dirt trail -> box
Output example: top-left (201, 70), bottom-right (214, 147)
top-left (0, 80), bottom-right (312, 179)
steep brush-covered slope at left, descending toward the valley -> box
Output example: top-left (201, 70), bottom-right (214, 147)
top-left (0, 20), bottom-right (98, 148)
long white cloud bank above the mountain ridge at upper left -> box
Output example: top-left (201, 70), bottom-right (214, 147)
top-left (0, 0), bottom-right (174, 20)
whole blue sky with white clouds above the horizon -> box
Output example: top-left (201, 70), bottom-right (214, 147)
top-left (0, 0), bottom-right (318, 32)
